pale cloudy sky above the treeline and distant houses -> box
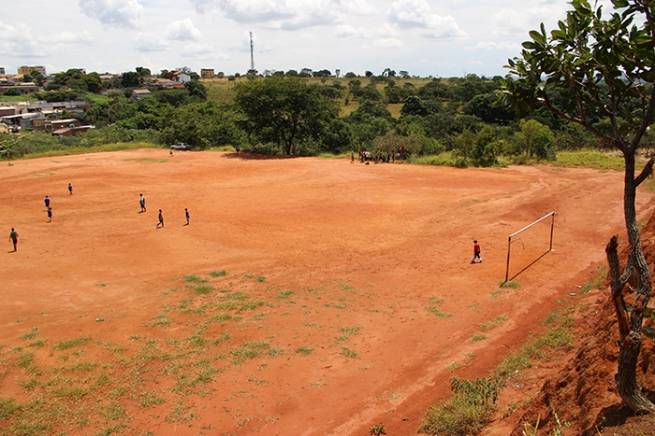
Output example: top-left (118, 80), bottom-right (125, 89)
top-left (0, 0), bottom-right (580, 76)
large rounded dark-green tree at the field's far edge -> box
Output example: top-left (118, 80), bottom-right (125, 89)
top-left (235, 77), bottom-right (337, 155)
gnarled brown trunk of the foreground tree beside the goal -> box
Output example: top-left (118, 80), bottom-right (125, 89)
top-left (608, 149), bottom-right (655, 413)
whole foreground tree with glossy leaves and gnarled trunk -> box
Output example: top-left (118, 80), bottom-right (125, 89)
top-left (507, 0), bottom-right (655, 413)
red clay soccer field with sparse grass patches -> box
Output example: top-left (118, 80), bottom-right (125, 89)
top-left (0, 150), bottom-right (653, 435)
